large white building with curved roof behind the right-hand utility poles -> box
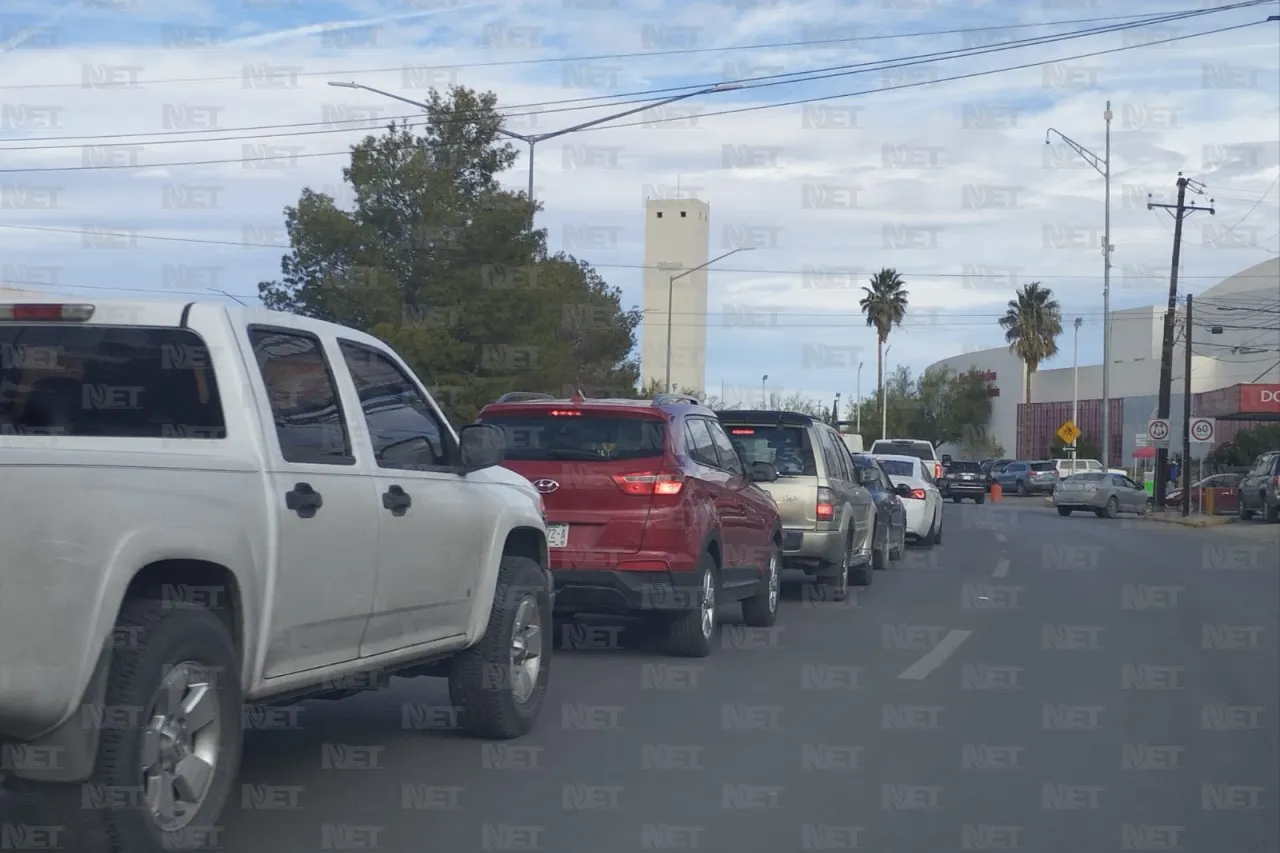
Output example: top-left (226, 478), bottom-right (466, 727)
top-left (929, 259), bottom-right (1280, 465)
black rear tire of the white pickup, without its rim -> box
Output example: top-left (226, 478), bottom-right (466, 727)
top-left (6, 601), bottom-right (243, 853)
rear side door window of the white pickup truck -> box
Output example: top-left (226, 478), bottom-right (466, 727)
top-left (248, 327), bottom-right (355, 465)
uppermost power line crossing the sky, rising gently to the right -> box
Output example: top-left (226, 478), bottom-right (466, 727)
top-left (0, 7), bottom-right (1239, 91)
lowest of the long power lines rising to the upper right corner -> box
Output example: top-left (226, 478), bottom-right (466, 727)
top-left (0, 15), bottom-right (1262, 174)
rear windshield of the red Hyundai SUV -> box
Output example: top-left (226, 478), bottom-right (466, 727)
top-left (480, 410), bottom-right (667, 462)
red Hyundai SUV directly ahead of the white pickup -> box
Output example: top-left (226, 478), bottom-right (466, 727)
top-left (479, 392), bottom-right (782, 657)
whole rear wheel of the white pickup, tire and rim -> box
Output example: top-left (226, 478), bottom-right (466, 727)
top-left (6, 601), bottom-right (242, 853)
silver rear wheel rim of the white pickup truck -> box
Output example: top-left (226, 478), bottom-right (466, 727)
top-left (141, 661), bottom-right (223, 833)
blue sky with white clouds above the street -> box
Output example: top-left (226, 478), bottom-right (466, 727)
top-left (0, 0), bottom-right (1280, 398)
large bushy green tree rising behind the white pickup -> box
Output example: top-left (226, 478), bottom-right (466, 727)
top-left (259, 87), bottom-right (640, 423)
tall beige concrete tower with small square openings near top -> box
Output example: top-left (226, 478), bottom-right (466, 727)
top-left (640, 199), bottom-right (710, 392)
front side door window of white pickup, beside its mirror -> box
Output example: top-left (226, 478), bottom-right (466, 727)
top-left (338, 341), bottom-right (451, 470)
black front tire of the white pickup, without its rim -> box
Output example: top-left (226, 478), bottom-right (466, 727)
top-left (449, 557), bottom-right (554, 740)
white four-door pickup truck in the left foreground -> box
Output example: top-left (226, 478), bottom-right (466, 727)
top-left (0, 297), bottom-right (553, 853)
